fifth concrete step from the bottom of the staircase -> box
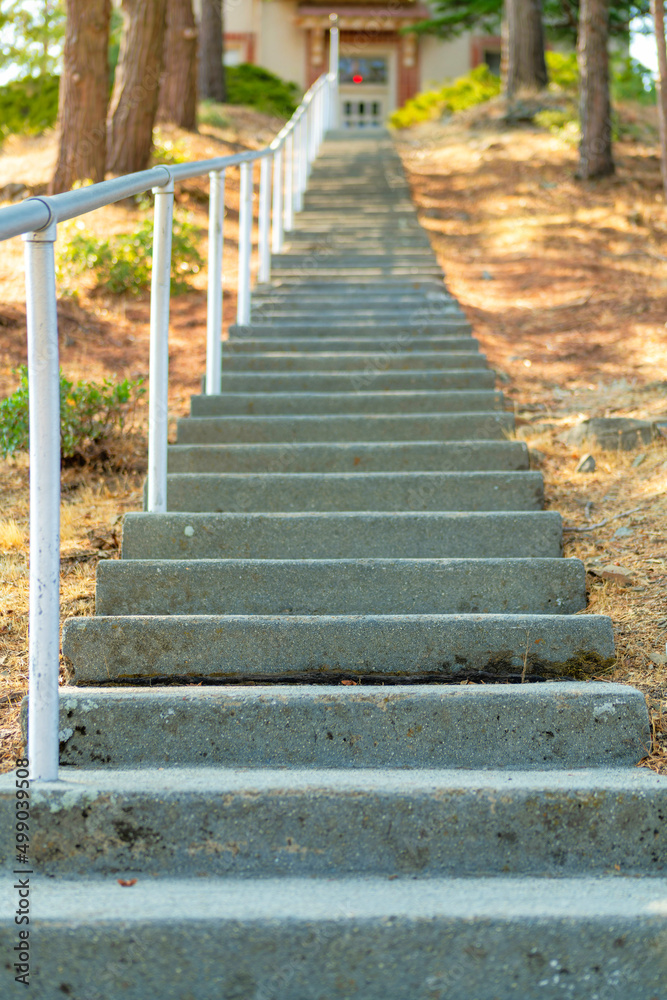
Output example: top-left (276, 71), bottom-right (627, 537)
top-left (95, 558), bottom-right (586, 616)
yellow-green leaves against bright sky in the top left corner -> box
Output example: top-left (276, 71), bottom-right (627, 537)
top-left (0, 0), bottom-right (65, 76)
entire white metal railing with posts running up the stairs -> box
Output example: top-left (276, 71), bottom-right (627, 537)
top-left (0, 25), bottom-right (338, 781)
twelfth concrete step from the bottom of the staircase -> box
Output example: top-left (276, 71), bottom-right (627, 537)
top-left (224, 351), bottom-right (486, 372)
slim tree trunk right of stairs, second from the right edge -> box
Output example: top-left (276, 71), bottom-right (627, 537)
top-left (577, 0), bottom-right (614, 180)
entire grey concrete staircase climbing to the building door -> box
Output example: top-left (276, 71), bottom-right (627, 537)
top-left (0, 133), bottom-right (667, 1000)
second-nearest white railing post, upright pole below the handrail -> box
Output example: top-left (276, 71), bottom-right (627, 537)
top-left (147, 179), bottom-right (174, 514)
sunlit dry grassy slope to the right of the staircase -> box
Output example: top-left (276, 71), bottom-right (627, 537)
top-left (399, 106), bottom-right (667, 773)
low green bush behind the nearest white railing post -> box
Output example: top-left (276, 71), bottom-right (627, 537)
top-left (0, 365), bottom-right (146, 458)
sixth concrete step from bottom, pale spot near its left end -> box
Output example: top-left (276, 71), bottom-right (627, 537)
top-left (123, 511), bottom-right (563, 559)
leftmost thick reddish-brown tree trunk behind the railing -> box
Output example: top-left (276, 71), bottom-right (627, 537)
top-left (49, 0), bottom-right (111, 194)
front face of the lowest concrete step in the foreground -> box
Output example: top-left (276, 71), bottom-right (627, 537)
top-left (0, 908), bottom-right (665, 1000)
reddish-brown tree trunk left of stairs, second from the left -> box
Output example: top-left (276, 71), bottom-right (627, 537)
top-left (107, 0), bottom-right (167, 174)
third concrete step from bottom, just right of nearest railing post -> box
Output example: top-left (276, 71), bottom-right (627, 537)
top-left (51, 684), bottom-right (650, 772)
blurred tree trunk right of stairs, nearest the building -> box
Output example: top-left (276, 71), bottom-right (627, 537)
top-left (505, 0), bottom-right (547, 98)
